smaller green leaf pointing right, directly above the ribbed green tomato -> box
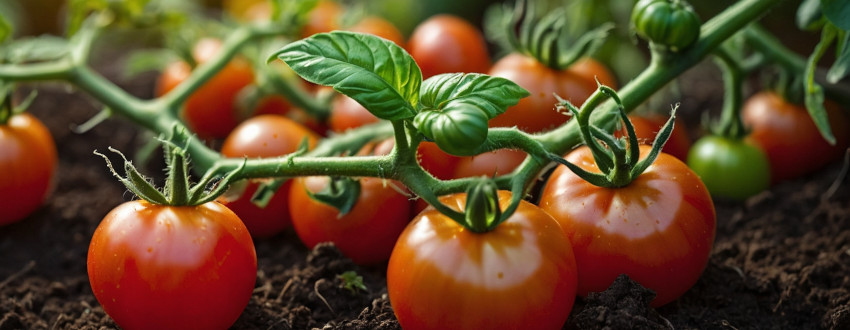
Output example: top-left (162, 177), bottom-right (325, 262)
top-left (420, 73), bottom-right (529, 119)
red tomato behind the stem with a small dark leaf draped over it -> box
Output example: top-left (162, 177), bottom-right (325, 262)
top-left (289, 176), bottom-right (410, 265)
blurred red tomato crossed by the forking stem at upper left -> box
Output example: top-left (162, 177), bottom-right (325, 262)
top-left (156, 39), bottom-right (254, 139)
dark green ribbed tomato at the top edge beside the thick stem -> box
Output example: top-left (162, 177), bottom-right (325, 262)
top-left (632, 0), bottom-right (702, 51)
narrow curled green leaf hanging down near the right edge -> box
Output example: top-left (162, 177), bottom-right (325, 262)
top-left (805, 24), bottom-right (838, 145)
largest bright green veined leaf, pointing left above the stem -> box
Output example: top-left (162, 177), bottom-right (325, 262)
top-left (273, 31), bottom-right (422, 120)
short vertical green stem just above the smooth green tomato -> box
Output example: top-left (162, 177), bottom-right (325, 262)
top-left (714, 47), bottom-right (746, 139)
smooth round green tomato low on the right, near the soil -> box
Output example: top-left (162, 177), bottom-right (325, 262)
top-left (688, 136), bottom-right (770, 200)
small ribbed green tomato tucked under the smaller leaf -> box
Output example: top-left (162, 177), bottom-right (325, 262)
top-left (413, 106), bottom-right (488, 156)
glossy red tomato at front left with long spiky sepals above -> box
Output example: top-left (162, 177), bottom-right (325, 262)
top-left (88, 201), bottom-right (257, 329)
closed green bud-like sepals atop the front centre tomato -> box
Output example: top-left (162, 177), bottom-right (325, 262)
top-left (464, 177), bottom-right (502, 233)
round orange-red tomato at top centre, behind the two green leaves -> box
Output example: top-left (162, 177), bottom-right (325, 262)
top-left (407, 14), bottom-right (490, 79)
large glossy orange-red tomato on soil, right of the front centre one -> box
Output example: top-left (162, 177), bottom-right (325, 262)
top-left (540, 145), bottom-right (716, 306)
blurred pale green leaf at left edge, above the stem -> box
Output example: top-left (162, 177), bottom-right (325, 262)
top-left (0, 35), bottom-right (70, 63)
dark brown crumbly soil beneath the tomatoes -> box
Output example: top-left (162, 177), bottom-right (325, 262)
top-left (0, 65), bottom-right (850, 330)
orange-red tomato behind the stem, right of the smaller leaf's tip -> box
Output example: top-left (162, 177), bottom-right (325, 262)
top-left (489, 53), bottom-right (596, 133)
